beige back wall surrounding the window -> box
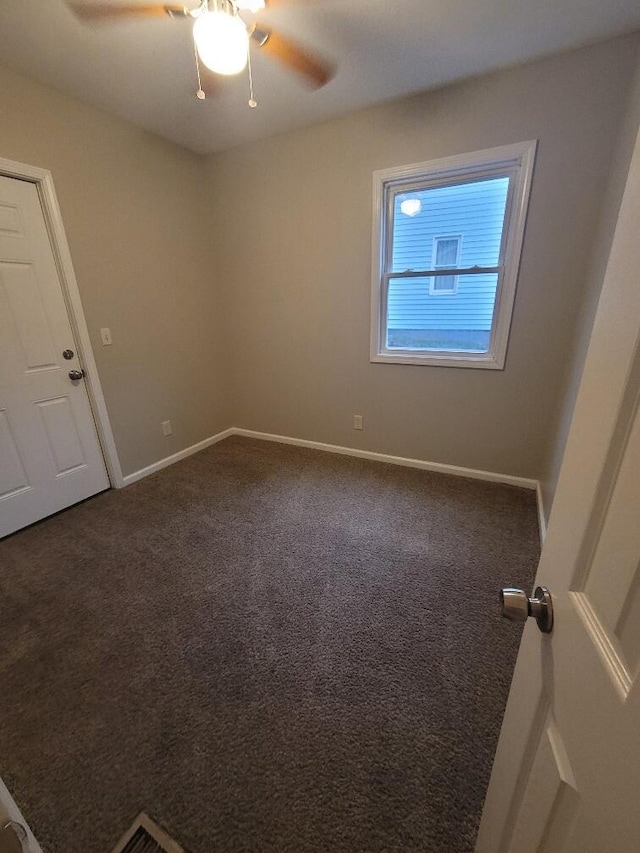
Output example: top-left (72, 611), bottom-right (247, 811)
top-left (208, 37), bottom-right (638, 477)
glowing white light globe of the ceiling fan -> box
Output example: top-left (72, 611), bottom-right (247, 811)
top-left (193, 12), bottom-right (249, 75)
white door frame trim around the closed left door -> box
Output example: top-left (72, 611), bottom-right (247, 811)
top-left (0, 157), bottom-right (125, 489)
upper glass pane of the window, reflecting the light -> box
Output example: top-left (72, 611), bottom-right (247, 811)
top-left (390, 177), bottom-right (509, 272)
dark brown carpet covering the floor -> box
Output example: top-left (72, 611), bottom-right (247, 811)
top-left (0, 438), bottom-right (538, 853)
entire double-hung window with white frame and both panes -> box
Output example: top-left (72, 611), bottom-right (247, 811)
top-left (371, 142), bottom-right (536, 369)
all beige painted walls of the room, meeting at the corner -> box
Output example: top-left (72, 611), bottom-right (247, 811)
top-left (0, 37), bottom-right (640, 490)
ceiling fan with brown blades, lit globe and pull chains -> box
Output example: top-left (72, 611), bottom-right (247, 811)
top-left (67, 0), bottom-right (335, 107)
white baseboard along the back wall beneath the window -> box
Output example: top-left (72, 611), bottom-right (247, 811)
top-left (230, 427), bottom-right (538, 490)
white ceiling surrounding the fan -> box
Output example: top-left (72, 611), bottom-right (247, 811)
top-left (0, 0), bottom-right (640, 153)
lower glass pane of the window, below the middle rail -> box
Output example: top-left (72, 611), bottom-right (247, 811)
top-left (387, 273), bottom-right (498, 352)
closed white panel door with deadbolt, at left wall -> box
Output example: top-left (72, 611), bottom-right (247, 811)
top-left (0, 177), bottom-right (109, 536)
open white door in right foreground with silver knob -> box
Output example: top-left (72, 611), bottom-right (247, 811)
top-left (476, 123), bottom-right (640, 853)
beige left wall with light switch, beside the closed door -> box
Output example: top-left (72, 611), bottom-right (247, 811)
top-left (0, 68), bottom-right (229, 474)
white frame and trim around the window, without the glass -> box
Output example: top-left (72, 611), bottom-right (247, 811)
top-left (370, 140), bottom-right (537, 370)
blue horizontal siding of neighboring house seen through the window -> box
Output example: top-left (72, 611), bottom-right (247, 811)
top-left (387, 178), bottom-right (509, 331)
